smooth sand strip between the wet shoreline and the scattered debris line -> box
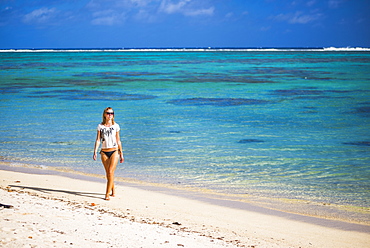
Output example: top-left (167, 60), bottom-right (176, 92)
top-left (0, 164), bottom-right (370, 247)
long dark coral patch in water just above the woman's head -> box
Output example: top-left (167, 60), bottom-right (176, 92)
top-left (31, 90), bottom-right (156, 101)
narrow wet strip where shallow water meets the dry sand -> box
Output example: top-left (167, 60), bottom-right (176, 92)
top-left (0, 161), bottom-right (370, 227)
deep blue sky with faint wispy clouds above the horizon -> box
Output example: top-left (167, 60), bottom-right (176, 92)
top-left (0, 0), bottom-right (370, 49)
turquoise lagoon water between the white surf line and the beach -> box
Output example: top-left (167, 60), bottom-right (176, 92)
top-left (0, 51), bottom-right (370, 207)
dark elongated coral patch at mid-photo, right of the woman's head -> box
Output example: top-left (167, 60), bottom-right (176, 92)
top-left (168, 98), bottom-right (268, 107)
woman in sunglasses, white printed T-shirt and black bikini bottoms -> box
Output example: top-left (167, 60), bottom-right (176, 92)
top-left (93, 107), bottom-right (124, 201)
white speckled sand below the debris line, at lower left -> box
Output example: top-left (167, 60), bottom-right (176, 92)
top-left (0, 190), bottom-right (232, 248)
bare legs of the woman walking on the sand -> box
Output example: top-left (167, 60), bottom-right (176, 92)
top-left (101, 152), bottom-right (119, 200)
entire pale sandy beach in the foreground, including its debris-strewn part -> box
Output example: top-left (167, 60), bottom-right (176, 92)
top-left (0, 166), bottom-right (370, 248)
